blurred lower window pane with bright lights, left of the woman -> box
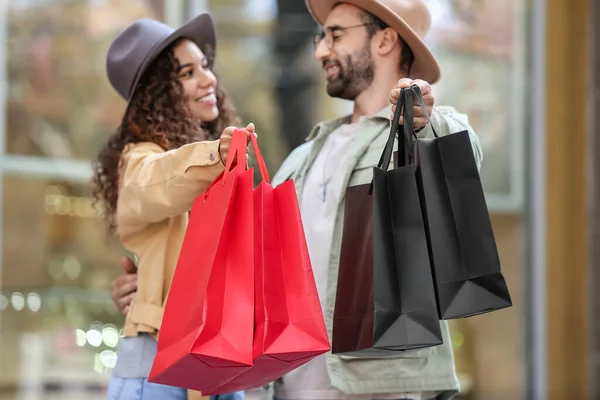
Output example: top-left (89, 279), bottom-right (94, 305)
top-left (0, 176), bottom-right (123, 398)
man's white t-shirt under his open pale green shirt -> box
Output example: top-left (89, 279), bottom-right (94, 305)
top-left (275, 124), bottom-right (421, 400)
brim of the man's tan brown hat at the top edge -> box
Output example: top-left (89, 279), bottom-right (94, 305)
top-left (306, 0), bottom-right (441, 84)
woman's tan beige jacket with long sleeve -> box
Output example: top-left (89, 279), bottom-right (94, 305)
top-left (116, 140), bottom-right (224, 338)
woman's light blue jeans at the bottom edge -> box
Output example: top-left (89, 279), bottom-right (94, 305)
top-left (106, 376), bottom-right (245, 400)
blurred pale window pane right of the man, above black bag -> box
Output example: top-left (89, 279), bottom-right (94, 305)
top-left (427, 0), bottom-right (528, 212)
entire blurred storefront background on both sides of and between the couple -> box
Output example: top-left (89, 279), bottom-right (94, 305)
top-left (0, 0), bottom-right (589, 400)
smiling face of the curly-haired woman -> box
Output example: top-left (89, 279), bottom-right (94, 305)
top-left (174, 39), bottom-right (219, 122)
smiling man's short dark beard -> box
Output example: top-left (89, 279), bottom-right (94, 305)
top-left (325, 43), bottom-right (375, 101)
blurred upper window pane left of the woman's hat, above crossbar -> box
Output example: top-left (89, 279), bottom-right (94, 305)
top-left (5, 0), bottom-right (163, 160)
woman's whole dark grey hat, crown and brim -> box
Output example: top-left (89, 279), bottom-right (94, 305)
top-left (106, 13), bottom-right (216, 101)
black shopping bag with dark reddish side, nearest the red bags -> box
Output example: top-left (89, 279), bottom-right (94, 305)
top-left (332, 87), bottom-right (443, 357)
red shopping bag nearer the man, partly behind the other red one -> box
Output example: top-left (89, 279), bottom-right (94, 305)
top-left (213, 133), bottom-right (330, 393)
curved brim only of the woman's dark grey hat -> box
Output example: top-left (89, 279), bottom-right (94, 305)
top-left (129, 13), bottom-right (217, 101)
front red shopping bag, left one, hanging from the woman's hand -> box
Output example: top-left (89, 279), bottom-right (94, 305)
top-left (149, 131), bottom-right (254, 393)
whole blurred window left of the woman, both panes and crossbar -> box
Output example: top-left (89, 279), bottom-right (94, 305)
top-left (0, 0), bottom-right (171, 400)
